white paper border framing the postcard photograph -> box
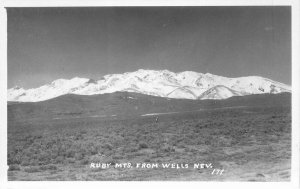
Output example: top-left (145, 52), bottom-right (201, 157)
top-left (0, 0), bottom-right (300, 189)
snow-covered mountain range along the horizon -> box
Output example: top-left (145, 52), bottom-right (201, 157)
top-left (7, 69), bottom-right (291, 102)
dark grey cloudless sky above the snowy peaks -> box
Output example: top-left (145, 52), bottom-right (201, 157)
top-left (7, 7), bottom-right (291, 88)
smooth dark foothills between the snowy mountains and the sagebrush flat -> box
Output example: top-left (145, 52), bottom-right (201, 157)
top-left (7, 92), bottom-right (291, 120)
